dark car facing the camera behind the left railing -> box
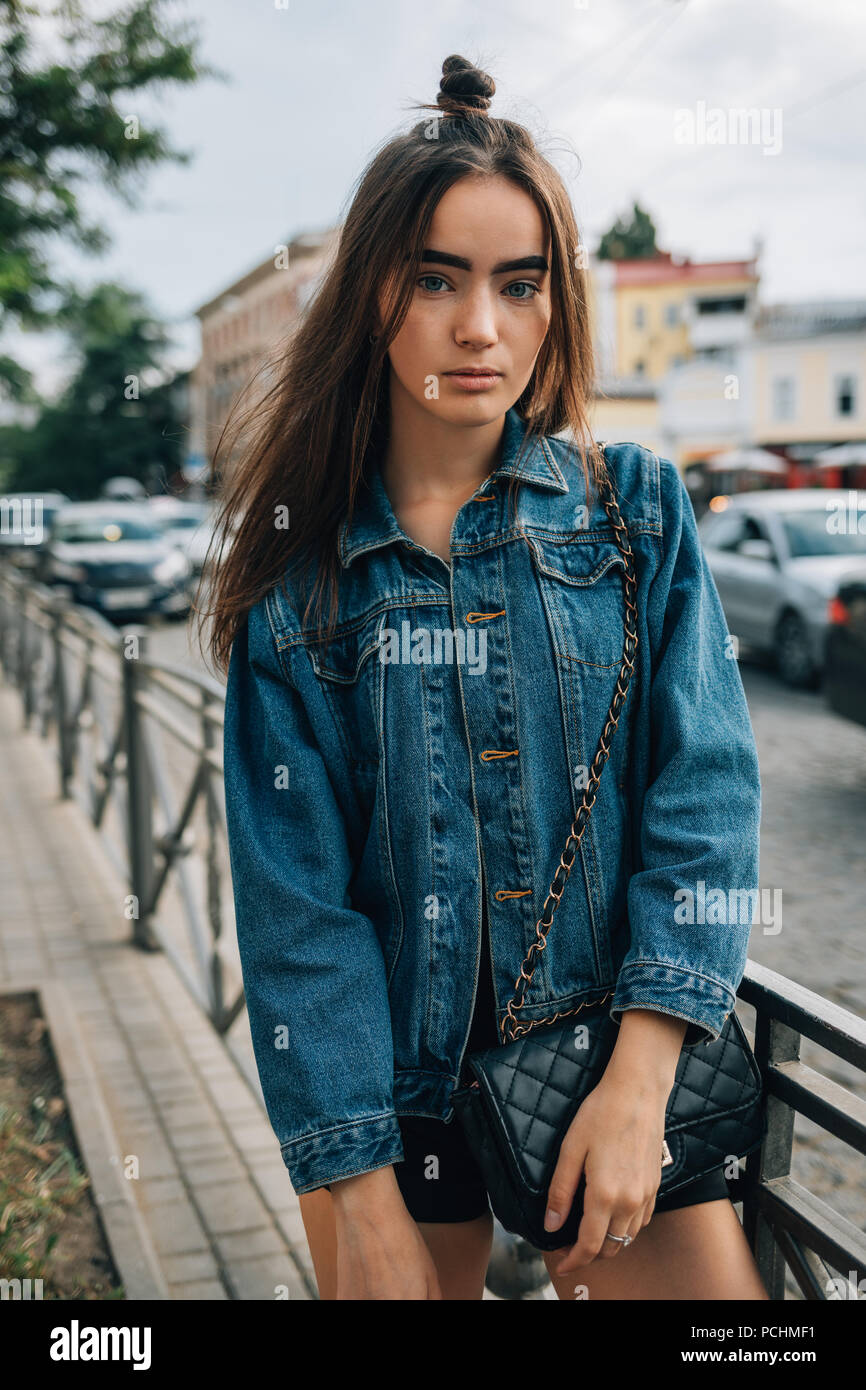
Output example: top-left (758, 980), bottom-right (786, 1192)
top-left (38, 502), bottom-right (189, 617)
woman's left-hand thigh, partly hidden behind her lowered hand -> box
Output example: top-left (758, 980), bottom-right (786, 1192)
top-left (299, 1187), bottom-right (493, 1301)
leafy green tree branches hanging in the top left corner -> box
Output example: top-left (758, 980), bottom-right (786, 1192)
top-left (0, 0), bottom-right (215, 400)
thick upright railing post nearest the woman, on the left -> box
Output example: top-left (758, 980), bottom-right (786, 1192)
top-left (121, 628), bottom-right (158, 951)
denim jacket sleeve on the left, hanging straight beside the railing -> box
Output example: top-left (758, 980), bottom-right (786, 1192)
top-left (224, 599), bottom-right (403, 1194)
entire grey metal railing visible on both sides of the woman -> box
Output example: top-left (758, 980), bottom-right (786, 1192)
top-left (0, 567), bottom-right (866, 1300)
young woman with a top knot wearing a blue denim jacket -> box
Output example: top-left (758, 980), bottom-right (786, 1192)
top-left (213, 57), bottom-right (766, 1300)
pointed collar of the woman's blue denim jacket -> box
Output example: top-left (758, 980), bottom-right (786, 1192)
top-left (338, 407), bottom-right (569, 569)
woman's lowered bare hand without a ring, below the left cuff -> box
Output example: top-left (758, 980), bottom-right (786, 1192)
top-left (331, 1166), bottom-right (442, 1301)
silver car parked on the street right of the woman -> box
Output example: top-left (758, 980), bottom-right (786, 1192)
top-left (698, 488), bottom-right (866, 687)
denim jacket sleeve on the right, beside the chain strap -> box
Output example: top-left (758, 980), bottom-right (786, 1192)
top-left (610, 459), bottom-right (760, 1047)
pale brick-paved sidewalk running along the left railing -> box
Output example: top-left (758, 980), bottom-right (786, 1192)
top-left (0, 687), bottom-right (316, 1300)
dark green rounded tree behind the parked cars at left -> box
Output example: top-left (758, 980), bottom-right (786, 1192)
top-left (0, 282), bottom-right (186, 498)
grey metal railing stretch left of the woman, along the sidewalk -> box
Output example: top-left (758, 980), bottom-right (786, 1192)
top-left (0, 567), bottom-right (243, 1034)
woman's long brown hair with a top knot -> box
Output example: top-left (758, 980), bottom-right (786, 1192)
top-left (196, 56), bottom-right (605, 670)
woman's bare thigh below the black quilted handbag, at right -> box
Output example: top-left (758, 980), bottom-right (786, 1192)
top-left (545, 1198), bottom-right (769, 1301)
